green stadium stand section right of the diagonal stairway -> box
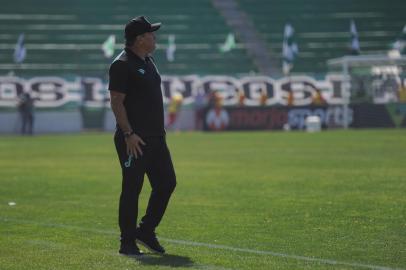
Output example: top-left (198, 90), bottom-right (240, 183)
top-left (237, 0), bottom-right (406, 75)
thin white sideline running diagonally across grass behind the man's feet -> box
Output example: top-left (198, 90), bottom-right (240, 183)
top-left (0, 217), bottom-right (406, 270)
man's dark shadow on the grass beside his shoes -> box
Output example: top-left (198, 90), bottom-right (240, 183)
top-left (137, 254), bottom-right (194, 267)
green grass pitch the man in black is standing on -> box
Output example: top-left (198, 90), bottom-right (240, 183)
top-left (0, 130), bottom-right (406, 270)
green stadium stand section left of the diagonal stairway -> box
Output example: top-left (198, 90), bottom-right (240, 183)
top-left (0, 0), bottom-right (256, 77)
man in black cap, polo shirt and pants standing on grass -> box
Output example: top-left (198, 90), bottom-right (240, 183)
top-left (109, 16), bottom-right (176, 255)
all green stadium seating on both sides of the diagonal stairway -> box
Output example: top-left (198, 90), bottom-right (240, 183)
top-left (0, 0), bottom-right (406, 77)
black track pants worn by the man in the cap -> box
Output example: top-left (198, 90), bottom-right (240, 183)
top-left (114, 130), bottom-right (176, 240)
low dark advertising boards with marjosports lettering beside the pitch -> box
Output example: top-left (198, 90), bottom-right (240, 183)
top-left (204, 103), bottom-right (406, 131)
